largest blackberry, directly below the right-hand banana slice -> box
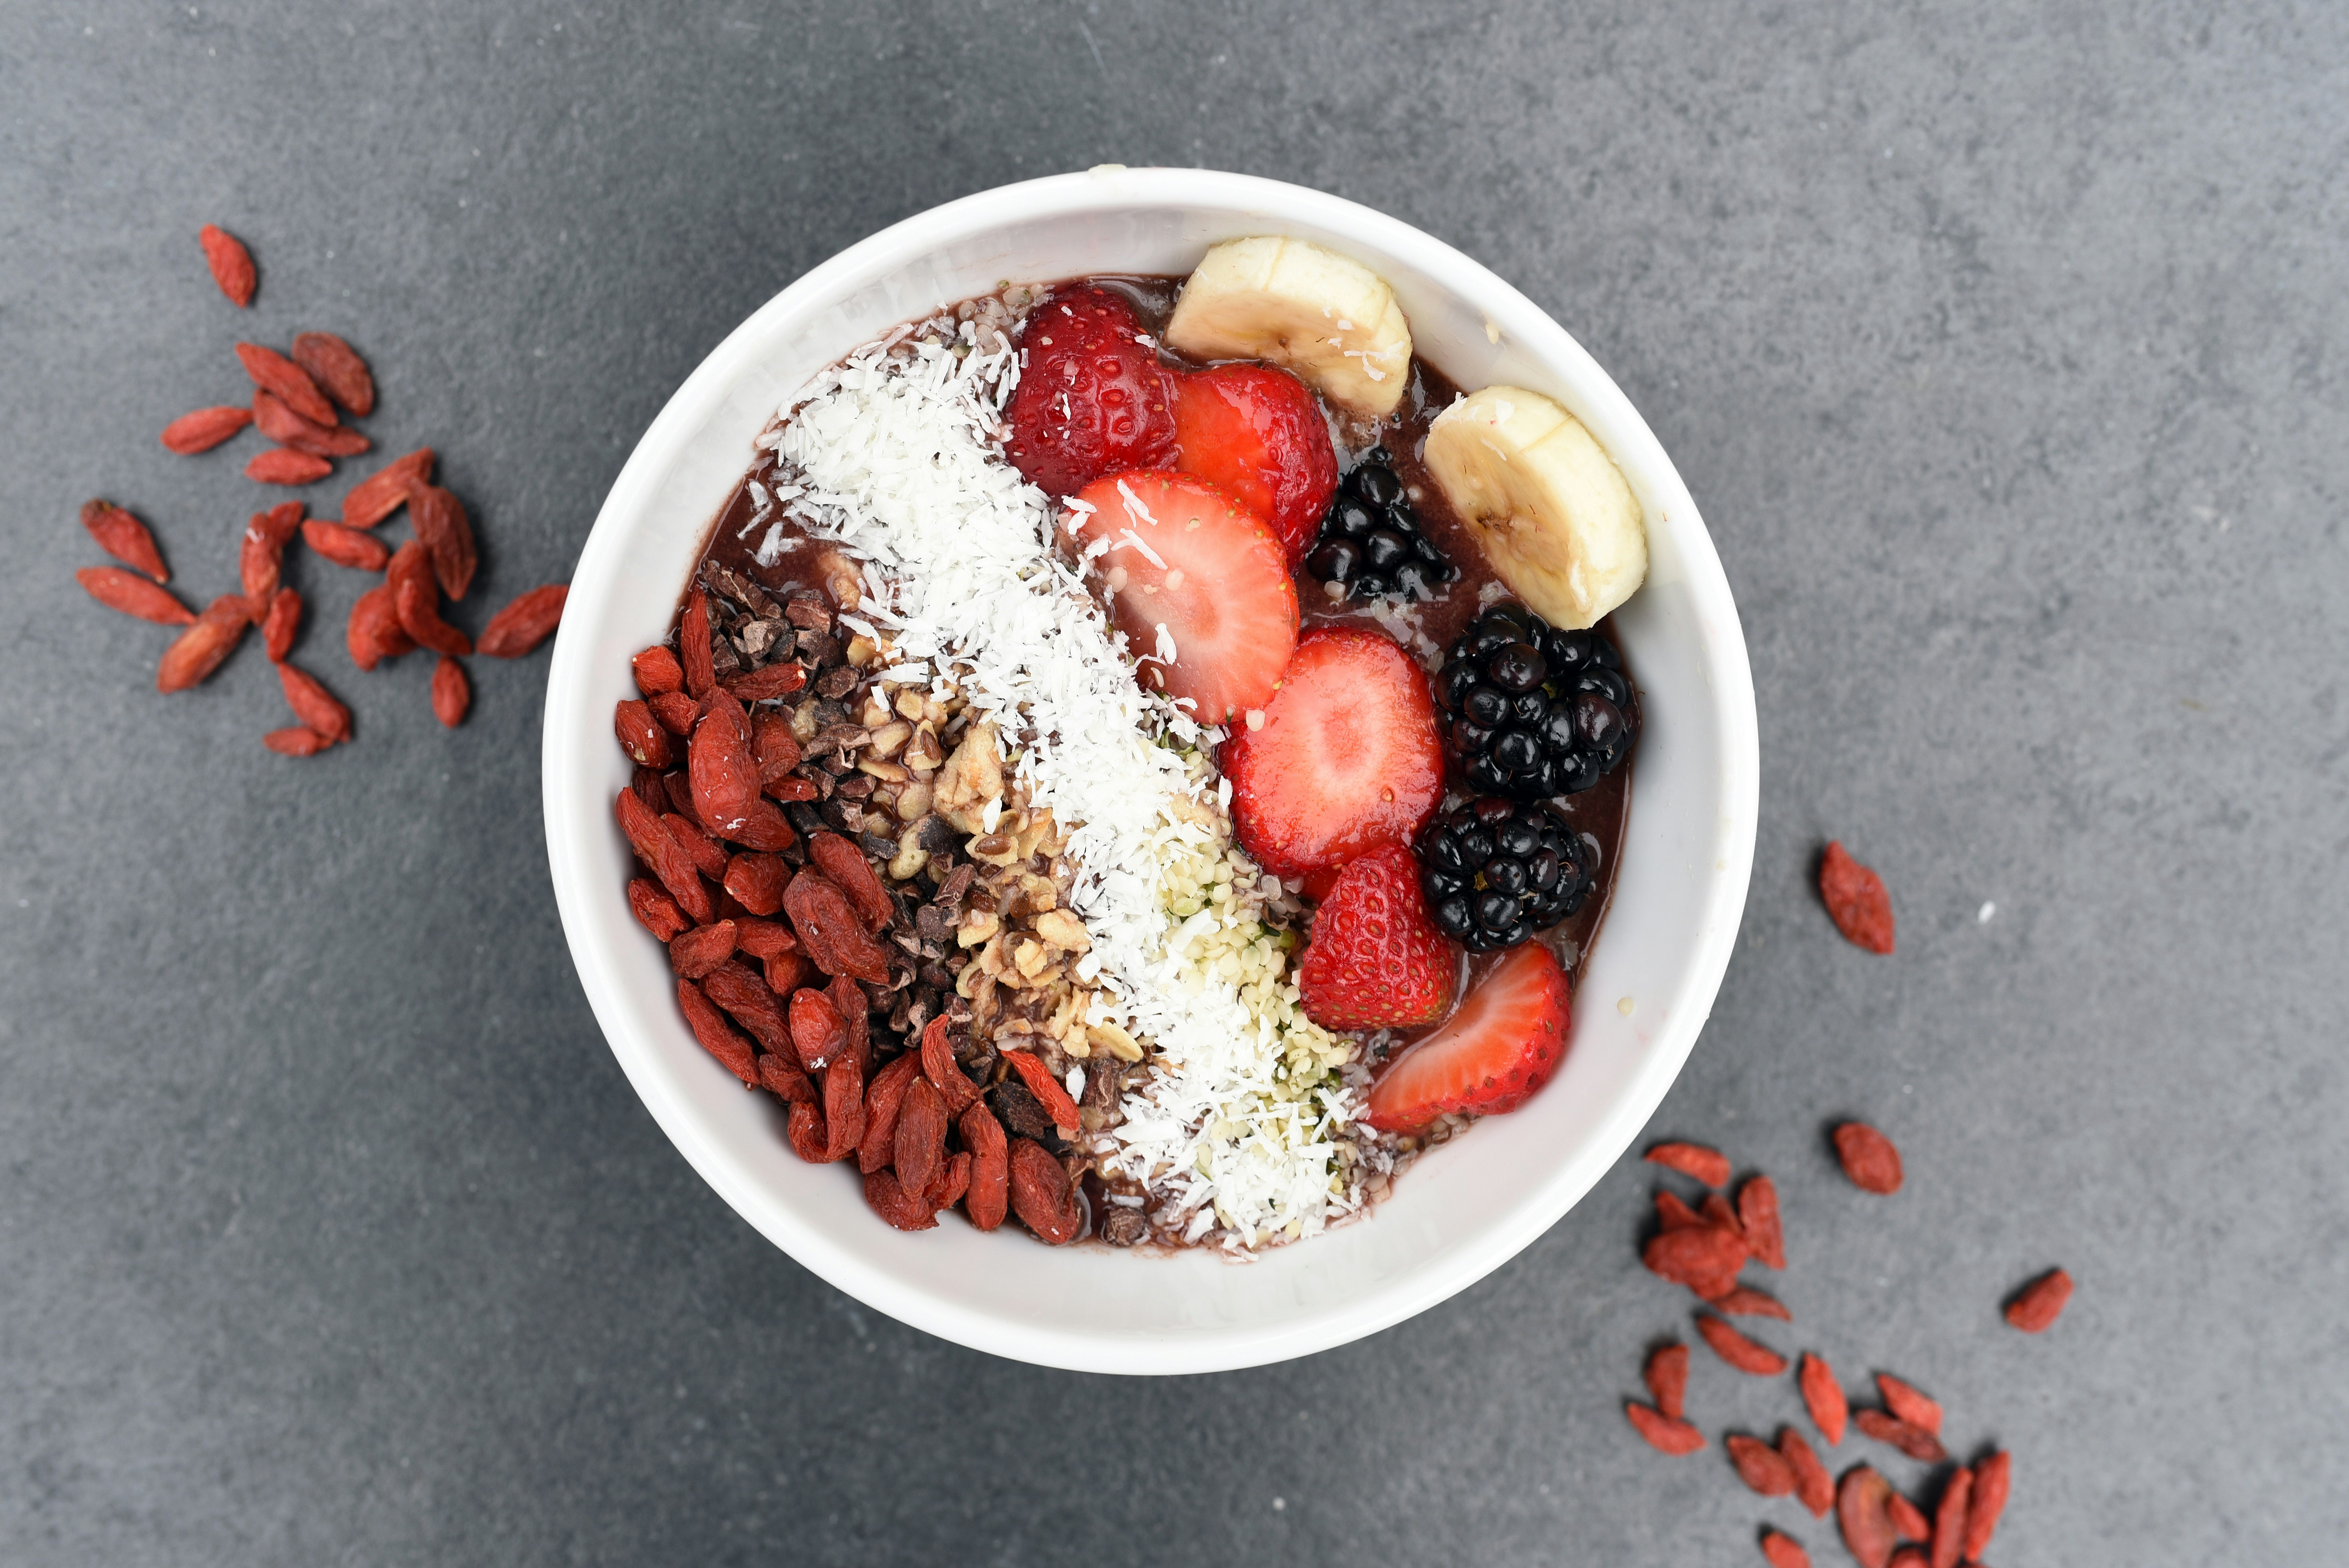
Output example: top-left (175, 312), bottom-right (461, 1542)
top-left (1435, 603), bottom-right (1640, 800)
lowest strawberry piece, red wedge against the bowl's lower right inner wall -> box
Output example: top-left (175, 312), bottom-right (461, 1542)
top-left (1367, 941), bottom-right (1574, 1131)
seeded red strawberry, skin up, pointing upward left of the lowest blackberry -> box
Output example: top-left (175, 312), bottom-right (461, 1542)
top-left (1297, 845), bottom-right (1459, 1028)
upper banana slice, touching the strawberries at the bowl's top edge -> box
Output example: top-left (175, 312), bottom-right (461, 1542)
top-left (1165, 235), bottom-right (1412, 413)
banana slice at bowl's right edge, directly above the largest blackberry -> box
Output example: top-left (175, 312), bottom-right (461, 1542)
top-left (1426, 387), bottom-right (1647, 629)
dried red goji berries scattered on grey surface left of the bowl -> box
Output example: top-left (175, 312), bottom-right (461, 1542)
top-left (75, 225), bottom-right (566, 756)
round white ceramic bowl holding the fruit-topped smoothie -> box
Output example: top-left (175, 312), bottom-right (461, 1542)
top-left (545, 167), bottom-right (1757, 1373)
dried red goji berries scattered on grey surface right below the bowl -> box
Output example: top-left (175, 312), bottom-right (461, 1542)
top-left (1623, 845), bottom-right (2072, 1568)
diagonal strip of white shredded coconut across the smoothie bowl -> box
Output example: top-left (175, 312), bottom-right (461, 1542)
top-left (761, 319), bottom-right (1369, 1251)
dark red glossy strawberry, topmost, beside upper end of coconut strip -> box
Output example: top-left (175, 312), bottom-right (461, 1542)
top-left (1003, 286), bottom-right (1174, 495)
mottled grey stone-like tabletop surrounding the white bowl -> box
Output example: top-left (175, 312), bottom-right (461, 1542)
top-left (0, 0), bottom-right (2349, 1568)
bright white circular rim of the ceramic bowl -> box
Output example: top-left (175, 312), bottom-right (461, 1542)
top-left (543, 164), bottom-right (1759, 1373)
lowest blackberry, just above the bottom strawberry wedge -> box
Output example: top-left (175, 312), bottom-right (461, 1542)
top-left (1419, 796), bottom-right (1600, 953)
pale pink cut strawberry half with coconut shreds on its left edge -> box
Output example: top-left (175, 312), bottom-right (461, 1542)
top-left (1059, 469), bottom-right (1306, 723)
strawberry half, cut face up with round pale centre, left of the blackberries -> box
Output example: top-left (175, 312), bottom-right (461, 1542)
top-left (1219, 627), bottom-right (1445, 878)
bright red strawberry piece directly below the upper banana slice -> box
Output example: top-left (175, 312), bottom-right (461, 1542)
top-left (1174, 364), bottom-right (1337, 570)
